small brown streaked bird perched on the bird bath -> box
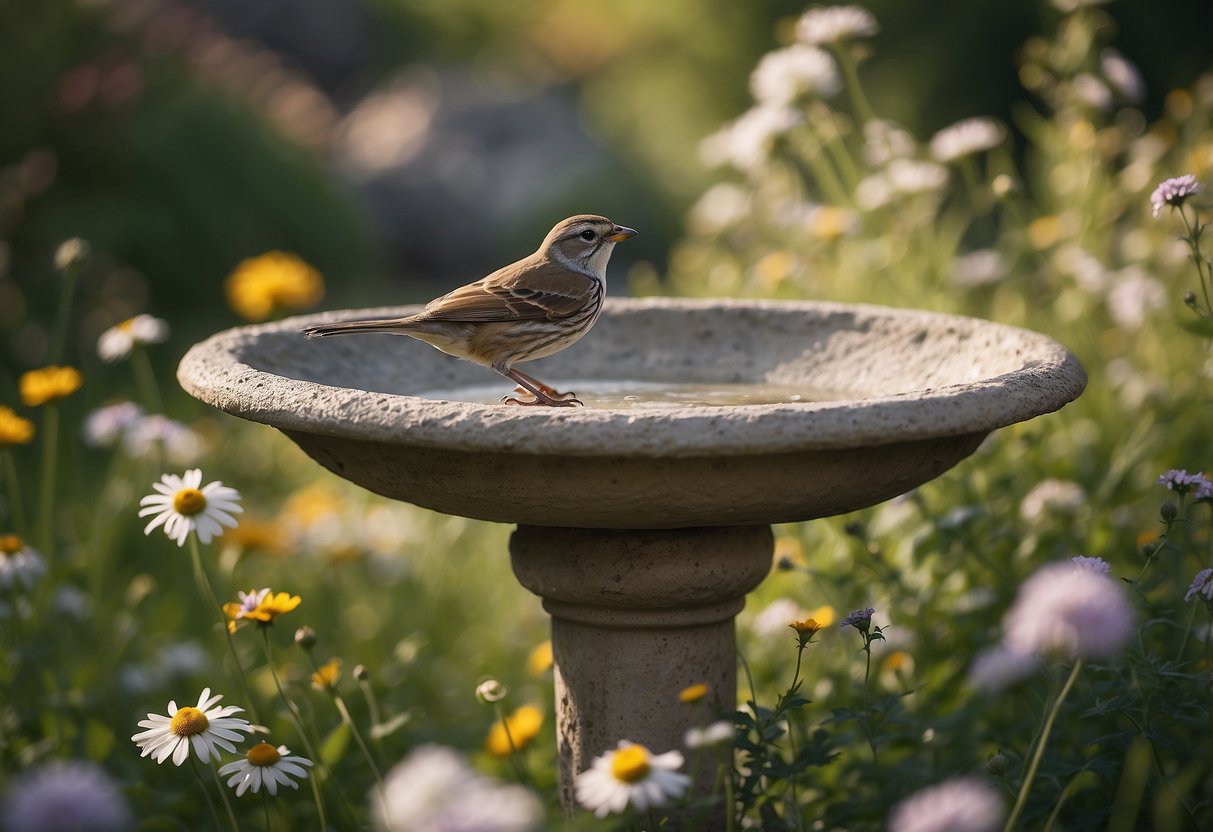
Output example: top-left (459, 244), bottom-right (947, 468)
top-left (303, 213), bottom-right (636, 408)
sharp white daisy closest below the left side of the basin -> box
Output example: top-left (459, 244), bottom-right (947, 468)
top-left (139, 468), bottom-right (244, 546)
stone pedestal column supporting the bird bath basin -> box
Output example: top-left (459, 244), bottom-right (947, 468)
top-left (509, 526), bottom-right (771, 828)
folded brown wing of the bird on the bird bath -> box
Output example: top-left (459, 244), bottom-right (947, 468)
top-left (418, 261), bottom-right (597, 324)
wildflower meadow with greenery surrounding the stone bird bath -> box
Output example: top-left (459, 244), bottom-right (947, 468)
top-left (0, 0), bottom-right (1213, 832)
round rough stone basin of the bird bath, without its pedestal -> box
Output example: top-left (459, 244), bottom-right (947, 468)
top-left (178, 300), bottom-right (1086, 529)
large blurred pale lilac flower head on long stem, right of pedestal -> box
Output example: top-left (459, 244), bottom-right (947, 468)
top-left (1003, 562), bottom-right (1133, 659)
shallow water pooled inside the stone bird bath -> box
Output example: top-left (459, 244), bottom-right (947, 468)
top-left (417, 378), bottom-right (855, 410)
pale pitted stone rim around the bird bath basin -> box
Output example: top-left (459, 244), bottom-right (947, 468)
top-left (177, 298), bottom-right (1087, 457)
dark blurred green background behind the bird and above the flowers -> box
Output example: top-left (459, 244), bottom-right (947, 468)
top-left (0, 0), bottom-right (1211, 377)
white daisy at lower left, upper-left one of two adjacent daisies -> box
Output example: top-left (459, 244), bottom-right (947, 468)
top-left (131, 688), bottom-right (252, 765)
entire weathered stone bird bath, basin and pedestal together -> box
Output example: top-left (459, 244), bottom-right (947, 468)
top-left (177, 300), bottom-right (1086, 809)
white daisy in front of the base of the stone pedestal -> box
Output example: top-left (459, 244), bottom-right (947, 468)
top-left (574, 740), bottom-right (690, 817)
